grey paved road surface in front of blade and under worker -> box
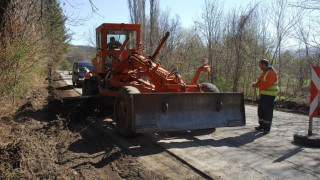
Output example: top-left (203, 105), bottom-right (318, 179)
top-left (60, 71), bottom-right (320, 179)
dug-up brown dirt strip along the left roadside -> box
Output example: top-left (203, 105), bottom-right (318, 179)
top-left (0, 72), bottom-right (209, 180)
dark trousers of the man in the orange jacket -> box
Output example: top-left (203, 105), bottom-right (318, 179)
top-left (258, 95), bottom-right (275, 131)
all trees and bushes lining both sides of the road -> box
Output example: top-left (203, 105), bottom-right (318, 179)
top-left (0, 0), bottom-right (320, 114)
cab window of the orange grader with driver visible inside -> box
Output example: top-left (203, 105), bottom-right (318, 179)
top-left (107, 30), bottom-right (137, 51)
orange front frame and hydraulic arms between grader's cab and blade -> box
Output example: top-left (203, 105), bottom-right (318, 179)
top-left (109, 32), bottom-right (210, 92)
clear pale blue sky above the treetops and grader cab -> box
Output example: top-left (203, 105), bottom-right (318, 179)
top-left (60, 0), bottom-right (254, 45)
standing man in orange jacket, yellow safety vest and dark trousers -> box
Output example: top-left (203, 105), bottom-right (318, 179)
top-left (251, 59), bottom-right (278, 134)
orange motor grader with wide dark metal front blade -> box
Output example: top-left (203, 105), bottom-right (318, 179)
top-left (82, 23), bottom-right (246, 136)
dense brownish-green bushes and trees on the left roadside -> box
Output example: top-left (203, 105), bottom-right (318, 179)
top-left (0, 0), bottom-right (69, 115)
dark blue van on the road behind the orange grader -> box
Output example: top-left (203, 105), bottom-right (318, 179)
top-left (72, 61), bottom-right (92, 87)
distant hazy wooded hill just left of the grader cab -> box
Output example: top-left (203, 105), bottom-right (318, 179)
top-left (66, 45), bottom-right (96, 64)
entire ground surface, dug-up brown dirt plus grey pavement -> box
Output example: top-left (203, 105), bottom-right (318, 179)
top-left (0, 71), bottom-right (320, 179)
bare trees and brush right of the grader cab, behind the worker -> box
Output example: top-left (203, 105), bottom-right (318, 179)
top-left (128, 0), bottom-right (320, 102)
